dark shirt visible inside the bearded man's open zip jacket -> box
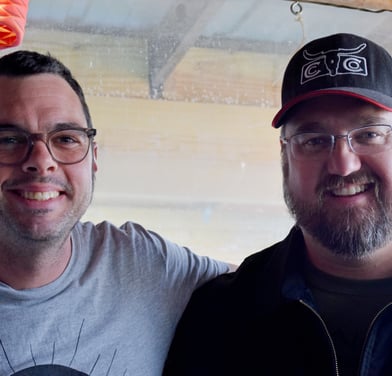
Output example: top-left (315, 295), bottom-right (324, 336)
top-left (306, 264), bottom-right (392, 376)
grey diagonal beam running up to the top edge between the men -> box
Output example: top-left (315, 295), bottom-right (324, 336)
top-left (148, 0), bottom-right (224, 99)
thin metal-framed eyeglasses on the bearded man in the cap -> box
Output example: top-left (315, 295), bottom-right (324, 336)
top-left (281, 124), bottom-right (392, 160)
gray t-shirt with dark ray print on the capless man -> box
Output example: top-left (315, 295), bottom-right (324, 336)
top-left (0, 222), bottom-right (228, 376)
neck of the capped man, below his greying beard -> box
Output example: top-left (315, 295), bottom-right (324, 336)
top-left (303, 232), bottom-right (392, 280)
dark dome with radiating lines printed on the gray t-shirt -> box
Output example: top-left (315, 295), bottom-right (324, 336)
top-left (0, 320), bottom-right (127, 376)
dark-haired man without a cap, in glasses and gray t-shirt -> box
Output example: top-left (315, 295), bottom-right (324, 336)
top-left (0, 51), bottom-right (233, 376)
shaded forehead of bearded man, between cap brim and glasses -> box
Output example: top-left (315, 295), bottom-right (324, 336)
top-left (284, 95), bottom-right (392, 133)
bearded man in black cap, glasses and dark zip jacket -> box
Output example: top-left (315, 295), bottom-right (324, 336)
top-left (164, 33), bottom-right (392, 376)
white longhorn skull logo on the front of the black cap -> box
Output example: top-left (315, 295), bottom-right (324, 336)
top-left (301, 43), bottom-right (367, 84)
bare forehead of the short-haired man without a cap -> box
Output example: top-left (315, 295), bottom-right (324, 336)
top-left (0, 73), bottom-right (85, 126)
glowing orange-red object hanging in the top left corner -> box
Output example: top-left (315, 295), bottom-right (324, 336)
top-left (0, 0), bottom-right (29, 49)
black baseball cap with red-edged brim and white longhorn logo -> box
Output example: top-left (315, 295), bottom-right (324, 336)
top-left (272, 33), bottom-right (392, 128)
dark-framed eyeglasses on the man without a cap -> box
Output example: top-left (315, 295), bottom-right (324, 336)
top-left (0, 127), bottom-right (97, 166)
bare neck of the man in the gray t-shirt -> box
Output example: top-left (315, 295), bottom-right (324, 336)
top-left (0, 237), bottom-right (72, 290)
